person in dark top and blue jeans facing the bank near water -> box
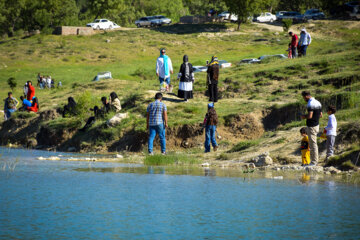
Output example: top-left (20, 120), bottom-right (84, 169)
top-left (203, 103), bottom-right (218, 153)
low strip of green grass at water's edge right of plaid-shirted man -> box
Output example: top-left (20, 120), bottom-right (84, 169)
top-left (144, 154), bottom-right (201, 166)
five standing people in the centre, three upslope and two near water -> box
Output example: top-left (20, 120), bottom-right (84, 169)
top-left (146, 48), bottom-right (220, 154)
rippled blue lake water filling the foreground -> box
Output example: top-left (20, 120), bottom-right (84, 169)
top-left (0, 148), bottom-right (360, 239)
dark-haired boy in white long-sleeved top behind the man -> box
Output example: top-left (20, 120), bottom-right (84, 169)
top-left (324, 106), bottom-right (337, 162)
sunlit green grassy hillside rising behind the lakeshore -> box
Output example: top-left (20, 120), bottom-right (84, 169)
top-left (0, 21), bottom-right (360, 158)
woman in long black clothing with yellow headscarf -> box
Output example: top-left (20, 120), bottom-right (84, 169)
top-left (207, 56), bottom-right (220, 102)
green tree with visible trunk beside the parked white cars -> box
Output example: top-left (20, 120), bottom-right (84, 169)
top-left (225, 0), bottom-right (266, 30)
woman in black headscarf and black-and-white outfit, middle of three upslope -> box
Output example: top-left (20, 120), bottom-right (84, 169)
top-left (178, 55), bottom-right (194, 102)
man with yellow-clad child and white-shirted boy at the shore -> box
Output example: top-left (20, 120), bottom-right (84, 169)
top-left (300, 91), bottom-right (337, 166)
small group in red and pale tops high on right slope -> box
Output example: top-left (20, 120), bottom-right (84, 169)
top-left (287, 28), bottom-right (311, 58)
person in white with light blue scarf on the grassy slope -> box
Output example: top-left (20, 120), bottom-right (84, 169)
top-left (156, 48), bottom-right (174, 91)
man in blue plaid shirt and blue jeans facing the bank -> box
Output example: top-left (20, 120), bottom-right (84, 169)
top-left (146, 93), bottom-right (167, 154)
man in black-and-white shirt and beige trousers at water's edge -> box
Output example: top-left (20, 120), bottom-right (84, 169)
top-left (301, 91), bottom-right (322, 166)
